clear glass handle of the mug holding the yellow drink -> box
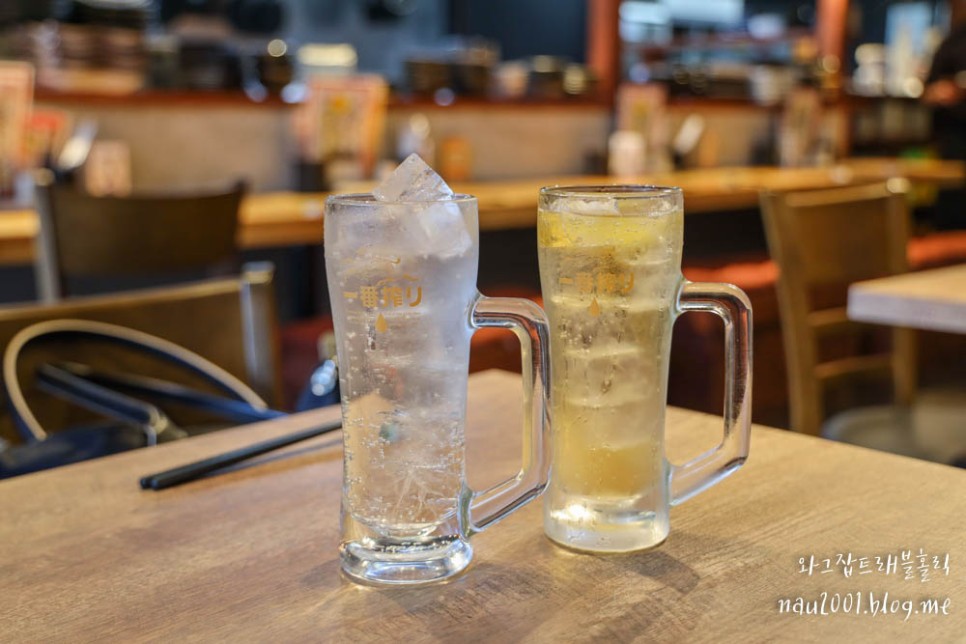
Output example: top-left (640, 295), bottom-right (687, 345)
top-left (671, 280), bottom-right (752, 505)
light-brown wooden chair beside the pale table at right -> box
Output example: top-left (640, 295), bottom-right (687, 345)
top-left (761, 184), bottom-right (916, 435)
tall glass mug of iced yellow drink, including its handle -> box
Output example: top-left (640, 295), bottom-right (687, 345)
top-left (537, 186), bottom-right (751, 552)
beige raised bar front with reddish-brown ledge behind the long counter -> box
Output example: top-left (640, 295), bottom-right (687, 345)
top-left (36, 90), bottom-right (928, 192)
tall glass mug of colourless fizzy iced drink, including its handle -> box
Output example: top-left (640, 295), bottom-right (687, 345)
top-left (325, 195), bottom-right (549, 584)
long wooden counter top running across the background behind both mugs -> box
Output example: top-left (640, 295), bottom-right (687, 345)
top-left (0, 158), bottom-right (966, 265)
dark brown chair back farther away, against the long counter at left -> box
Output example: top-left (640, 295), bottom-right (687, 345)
top-left (36, 171), bottom-right (245, 302)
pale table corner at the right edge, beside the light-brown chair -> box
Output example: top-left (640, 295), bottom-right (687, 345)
top-left (848, 264), bottom-right (966, 333)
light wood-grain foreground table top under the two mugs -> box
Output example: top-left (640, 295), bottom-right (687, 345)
top-left (0, 372), bottom-right (966, 643)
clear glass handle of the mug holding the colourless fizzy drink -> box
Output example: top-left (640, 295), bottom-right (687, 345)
top-left (464, 295), bottom-right (550, 534)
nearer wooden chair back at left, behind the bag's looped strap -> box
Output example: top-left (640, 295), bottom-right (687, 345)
top-left (0, 263), bottom-right (279, 443)
